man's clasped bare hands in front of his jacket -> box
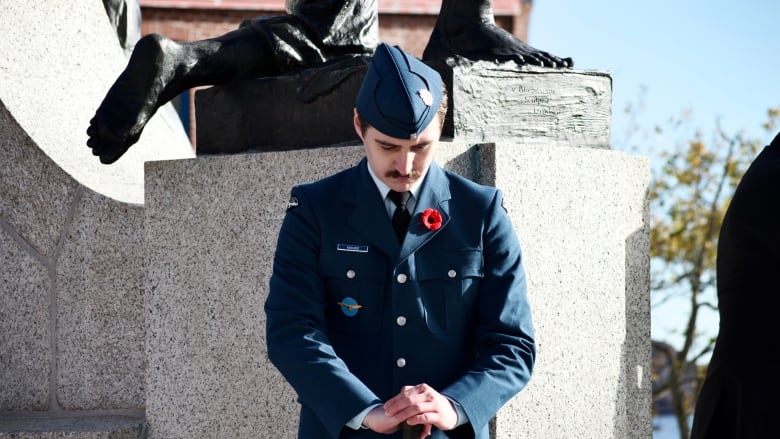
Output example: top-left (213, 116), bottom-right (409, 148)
top-left (363, 384), bottom-right (458, 439)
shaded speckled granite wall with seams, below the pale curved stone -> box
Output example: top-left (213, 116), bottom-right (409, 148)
top-left (0, 94), bottom-right (145, 417)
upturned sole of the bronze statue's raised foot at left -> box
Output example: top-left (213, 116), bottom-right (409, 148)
top-left (87, 35), bottom-right (170, 164)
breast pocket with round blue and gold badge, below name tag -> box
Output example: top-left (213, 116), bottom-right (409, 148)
top-left (320, 252), bottom-right (386, 335)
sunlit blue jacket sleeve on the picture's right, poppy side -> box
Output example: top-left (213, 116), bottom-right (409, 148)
top-left (442, 191), bottom-right (536, 437)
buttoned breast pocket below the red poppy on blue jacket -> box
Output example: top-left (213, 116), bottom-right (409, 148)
top-left (416, 249), bottom-right (483, 334)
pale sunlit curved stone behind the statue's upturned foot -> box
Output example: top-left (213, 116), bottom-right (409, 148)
top-left (0, 1), bottom-right (194, 204)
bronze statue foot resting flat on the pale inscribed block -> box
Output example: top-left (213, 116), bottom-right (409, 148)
top-left (423, 21), bottom-right (574, 68)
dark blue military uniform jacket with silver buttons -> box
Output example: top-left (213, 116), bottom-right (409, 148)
top-left (265, 159), bottom-right (536, 439)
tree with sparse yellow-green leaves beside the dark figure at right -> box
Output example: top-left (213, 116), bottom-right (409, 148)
top-left (628, 100), bottom-right (780, 439)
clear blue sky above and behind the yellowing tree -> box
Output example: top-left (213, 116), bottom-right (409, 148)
top-left (528, 0), bottom-right (780, 354)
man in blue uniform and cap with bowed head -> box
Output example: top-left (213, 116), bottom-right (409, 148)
top-left (265, 44), bottom-right (536, 439)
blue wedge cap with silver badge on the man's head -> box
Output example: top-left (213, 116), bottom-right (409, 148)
top-left (355, 43), bottom-right (442, 139)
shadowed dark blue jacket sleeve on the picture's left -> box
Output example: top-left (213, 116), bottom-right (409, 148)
top-left (265, 187), bottom-right (381, 438)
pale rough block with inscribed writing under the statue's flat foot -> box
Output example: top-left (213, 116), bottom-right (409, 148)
top-left (433, 61), bottom-right (612, 148)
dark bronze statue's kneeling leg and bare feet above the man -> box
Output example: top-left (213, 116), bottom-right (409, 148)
top-left (87, 0), bottom-right (573, 164)
